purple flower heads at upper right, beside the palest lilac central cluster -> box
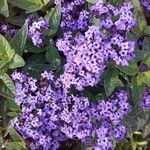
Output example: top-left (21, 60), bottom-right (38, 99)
top-left (90, 0), bottom-right (136, 66)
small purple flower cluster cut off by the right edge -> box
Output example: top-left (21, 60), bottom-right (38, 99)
top-left (140, 87), bottom-right (150, 109)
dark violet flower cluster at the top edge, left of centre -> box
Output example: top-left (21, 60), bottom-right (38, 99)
top-left (55, 0), bottom-right (89, 31)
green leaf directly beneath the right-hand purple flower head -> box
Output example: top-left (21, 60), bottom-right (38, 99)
top-left (116, 62), bottom-right (138, 76)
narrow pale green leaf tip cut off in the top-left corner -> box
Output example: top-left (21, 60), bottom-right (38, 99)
top-left (0, 0), bottom-right (9, 17)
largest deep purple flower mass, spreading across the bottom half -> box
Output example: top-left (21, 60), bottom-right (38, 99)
top-left (12, 71), bottom-right (131, 150)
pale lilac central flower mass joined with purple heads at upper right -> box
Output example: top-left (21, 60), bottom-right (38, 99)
top-left (57, 0), bottom-right (136, 91)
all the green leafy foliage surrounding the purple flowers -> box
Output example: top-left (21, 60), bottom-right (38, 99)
top-left (0, 0), bottom-right (150, 150)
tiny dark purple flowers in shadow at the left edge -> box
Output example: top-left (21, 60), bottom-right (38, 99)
top-left (0, 24), bottom-right (16, 37)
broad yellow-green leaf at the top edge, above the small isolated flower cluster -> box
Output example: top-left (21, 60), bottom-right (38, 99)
top-left (8, 0), bottom-right (43, 13)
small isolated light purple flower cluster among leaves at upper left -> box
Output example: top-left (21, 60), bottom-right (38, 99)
top-left (26, 16), bottom-right (49, 47)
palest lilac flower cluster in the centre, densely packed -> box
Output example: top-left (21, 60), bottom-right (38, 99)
top-left (57, 26), bottom-right (108, 90)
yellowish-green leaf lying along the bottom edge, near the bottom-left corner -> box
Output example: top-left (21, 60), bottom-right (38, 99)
top-left (4, 142), bottom-right (26, 150)
